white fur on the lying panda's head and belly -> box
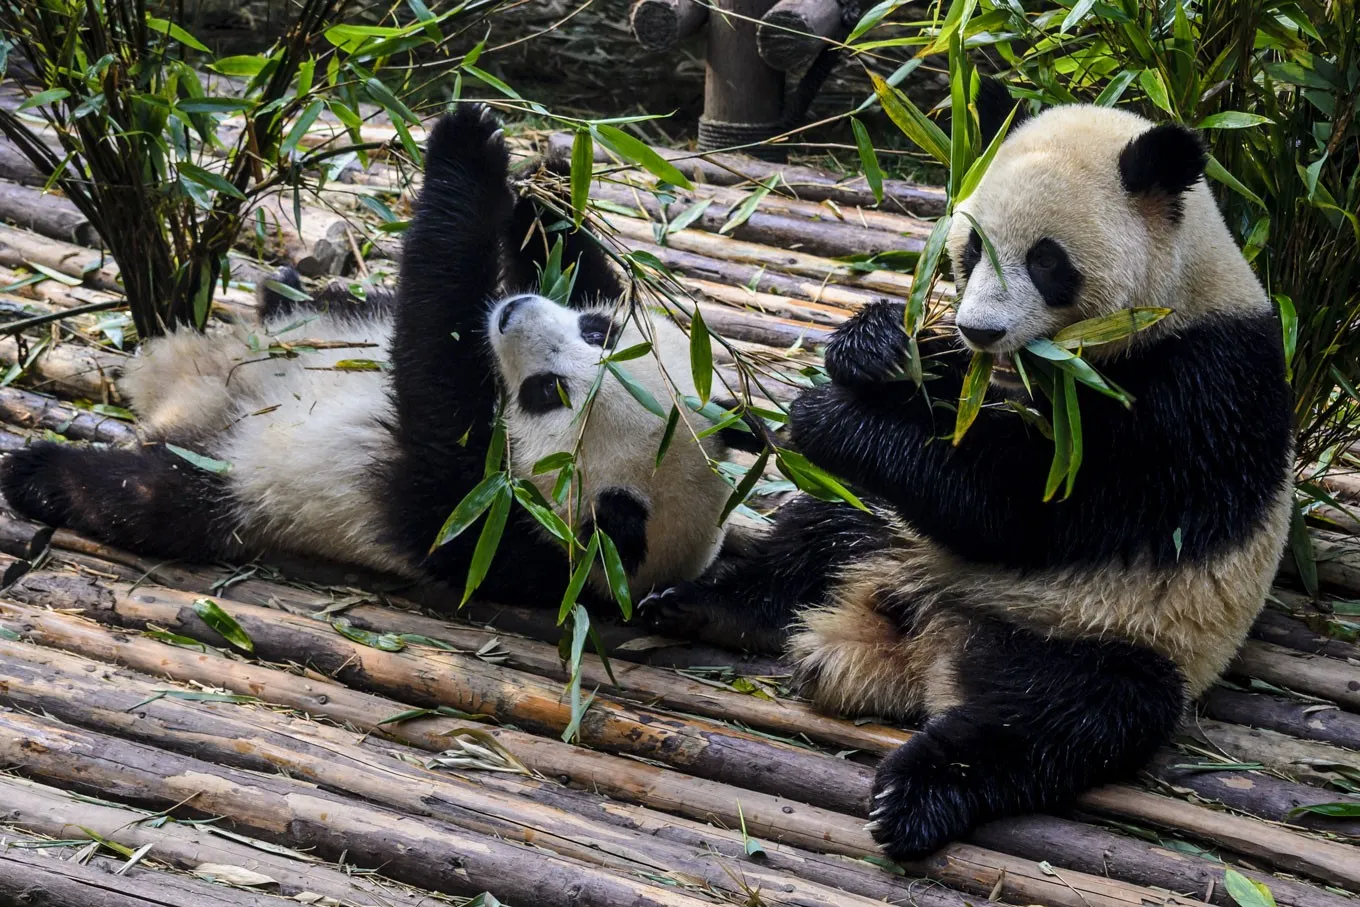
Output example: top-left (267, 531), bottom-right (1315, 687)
top-left (121, 298), bottom-right (729, 593)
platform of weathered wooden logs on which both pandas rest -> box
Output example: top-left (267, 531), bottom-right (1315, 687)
top-left (0, 122), bottom-right (1360, 907)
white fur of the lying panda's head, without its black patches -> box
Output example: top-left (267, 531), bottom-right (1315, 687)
top-left (487, 296), bottom-right (730, 593)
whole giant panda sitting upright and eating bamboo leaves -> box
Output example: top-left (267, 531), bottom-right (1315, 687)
top-left (642, 87), bottom-right (1293, 859)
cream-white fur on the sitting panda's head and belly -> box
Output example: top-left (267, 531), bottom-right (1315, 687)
top-left (790, 106), bottom-right (1292, 717)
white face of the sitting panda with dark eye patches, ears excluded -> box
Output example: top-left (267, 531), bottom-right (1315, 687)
top-left (948, 106), bottom-right (1213, 383)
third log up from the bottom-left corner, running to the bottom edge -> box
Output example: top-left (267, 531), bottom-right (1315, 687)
top-left (0, 713), bottom-right (710, 907)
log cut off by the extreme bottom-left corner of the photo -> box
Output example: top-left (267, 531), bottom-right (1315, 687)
top-left (0, 835), bottom-right (279, 907)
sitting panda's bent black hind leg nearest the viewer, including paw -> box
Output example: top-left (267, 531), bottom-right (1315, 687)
top-left (869, 623), bottom-right (1186, 859)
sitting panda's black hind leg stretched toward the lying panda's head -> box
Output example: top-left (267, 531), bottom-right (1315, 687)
top-left (641, 496), bottom-right (892, 654)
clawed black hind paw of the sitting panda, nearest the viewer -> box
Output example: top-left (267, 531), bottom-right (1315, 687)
top-left (868, 732), bottom-right (978, 862)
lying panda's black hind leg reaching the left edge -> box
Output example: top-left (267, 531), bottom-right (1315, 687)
top-left (0, 442), bottom-right (242, 562)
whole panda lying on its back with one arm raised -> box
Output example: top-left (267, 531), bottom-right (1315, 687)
top-left (0, 105), bottom-right (730, 606)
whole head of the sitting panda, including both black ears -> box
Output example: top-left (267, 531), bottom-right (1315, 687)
top-left (948, 82), bottom-right (1263, 383)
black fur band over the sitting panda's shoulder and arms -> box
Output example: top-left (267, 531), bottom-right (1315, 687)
top-left (792, 304), bottom-right (1292, 570)
